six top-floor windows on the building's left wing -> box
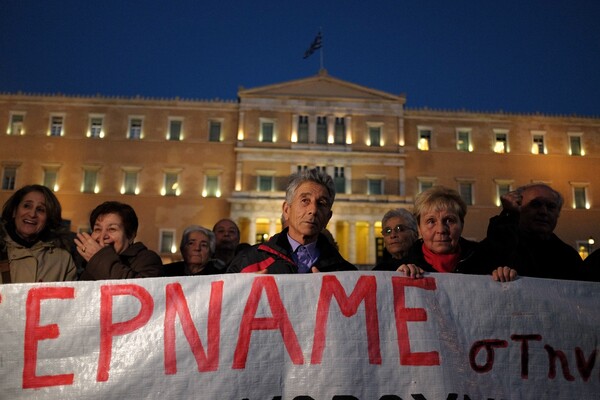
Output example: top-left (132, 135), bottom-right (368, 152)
top-left (6, 113), bottom-right (223, 142)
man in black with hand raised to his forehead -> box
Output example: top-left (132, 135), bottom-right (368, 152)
top-left (479, 183), bottom-right (585, 281)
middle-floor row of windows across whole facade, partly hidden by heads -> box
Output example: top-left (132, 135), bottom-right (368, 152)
top-left (2, 165), bottom-right (590, 209)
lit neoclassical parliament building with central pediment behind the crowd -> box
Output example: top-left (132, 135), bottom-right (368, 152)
top-left (0, 70), bottom-right (600, 268)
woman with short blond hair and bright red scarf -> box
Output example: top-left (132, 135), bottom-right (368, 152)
top-left (398, 186), bottom-right (477, 277)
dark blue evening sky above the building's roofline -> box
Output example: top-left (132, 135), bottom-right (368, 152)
top-left (0, 0), bottom-right (600, 116)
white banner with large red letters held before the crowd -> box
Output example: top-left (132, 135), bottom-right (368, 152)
top-left (0, 272), bottom-right (600, 400)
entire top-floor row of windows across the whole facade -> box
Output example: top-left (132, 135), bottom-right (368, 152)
top-left (7, 113), bottom-right (585, 156)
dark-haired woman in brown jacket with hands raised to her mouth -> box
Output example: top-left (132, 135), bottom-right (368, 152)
top-left (75, 201), bottom-right (162, 280)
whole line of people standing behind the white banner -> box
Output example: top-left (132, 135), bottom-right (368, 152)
top-left (0, 169), bottom-right (600, 284)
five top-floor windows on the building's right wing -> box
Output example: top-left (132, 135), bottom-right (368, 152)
top-left (417, 127), bottom-right (585, 156)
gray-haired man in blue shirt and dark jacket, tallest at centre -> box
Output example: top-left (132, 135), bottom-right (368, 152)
top-left (227, 169), bottom-right (356, 274)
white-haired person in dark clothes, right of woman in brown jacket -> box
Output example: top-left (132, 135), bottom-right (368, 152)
top-left (164, 225), bottom-right (225, 276)
